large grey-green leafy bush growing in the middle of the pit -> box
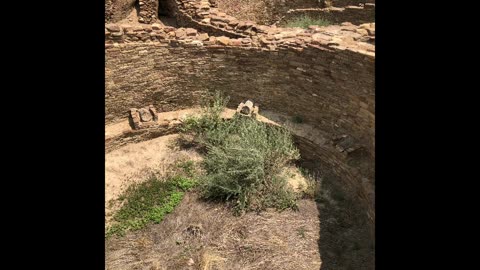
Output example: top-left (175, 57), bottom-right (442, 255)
top-left (184, 92), bottom-right (300, 212)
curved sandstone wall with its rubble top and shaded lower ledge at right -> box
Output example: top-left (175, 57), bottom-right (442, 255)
top-left (105, 1), bottom-right (375, 224)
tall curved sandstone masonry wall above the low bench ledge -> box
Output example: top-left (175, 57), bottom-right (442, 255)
top-left (105, 21), bottom-right (375, 152)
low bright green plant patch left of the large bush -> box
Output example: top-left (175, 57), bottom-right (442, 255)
top-left (106, 175), bottom-right (196, 238)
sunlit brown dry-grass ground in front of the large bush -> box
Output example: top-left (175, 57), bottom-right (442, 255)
top-left (106, 193), bottom-right (321, 270)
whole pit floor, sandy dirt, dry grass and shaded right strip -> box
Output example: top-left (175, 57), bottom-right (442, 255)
top-left (105, 111), bottom-right (375, 270)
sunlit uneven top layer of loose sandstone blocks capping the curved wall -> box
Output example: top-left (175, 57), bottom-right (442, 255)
top-left (105, 23), bottom-right (375, 55)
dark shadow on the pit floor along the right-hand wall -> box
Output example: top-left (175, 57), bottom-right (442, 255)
top-left (300, 160), bottom-right (375, 270)
